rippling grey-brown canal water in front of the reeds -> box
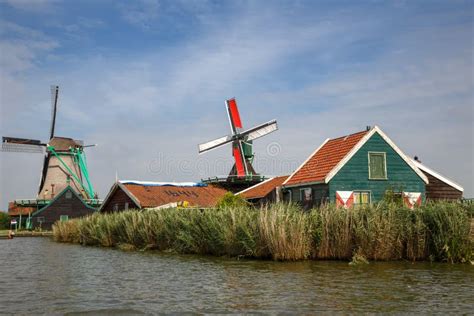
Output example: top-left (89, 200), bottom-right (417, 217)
top-left (0, 238), bottom-right (474, 315)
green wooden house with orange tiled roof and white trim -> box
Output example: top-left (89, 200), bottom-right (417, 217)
top-left (282, 126), bottom-right (428, 208)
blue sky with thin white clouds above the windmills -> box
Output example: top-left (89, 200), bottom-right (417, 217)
top-left (0, 0), bottom-right (474, 209)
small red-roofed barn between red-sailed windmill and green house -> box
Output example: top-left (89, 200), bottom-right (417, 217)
top-left (237, 175), bottom-right (288, 205)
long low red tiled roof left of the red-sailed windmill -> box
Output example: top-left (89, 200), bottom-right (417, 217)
top-left (123, 184), bottom-right (227, 208)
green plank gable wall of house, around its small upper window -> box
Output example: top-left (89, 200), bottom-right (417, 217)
top-left (329, 133), bottom-right (425, 202)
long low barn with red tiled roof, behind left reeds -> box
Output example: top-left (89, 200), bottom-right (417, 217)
top-left (100, 181), bottom-right (227, 212)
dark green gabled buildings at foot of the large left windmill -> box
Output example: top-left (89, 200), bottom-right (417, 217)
top-left (8, 186), bottom-right (99, 229)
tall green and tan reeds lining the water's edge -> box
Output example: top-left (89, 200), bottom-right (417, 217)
top-left (53, 203), bottom-right (474, 262)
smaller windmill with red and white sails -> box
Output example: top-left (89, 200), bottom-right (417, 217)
top-left (199, 98), bottom-right (278, 190)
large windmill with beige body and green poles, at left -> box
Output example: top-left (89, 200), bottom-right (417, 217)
top-left (1, 86), bottom-right (96, 200)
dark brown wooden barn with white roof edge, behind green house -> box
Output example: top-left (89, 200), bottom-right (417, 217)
top-left (413, 159), bottom-right (464, 200)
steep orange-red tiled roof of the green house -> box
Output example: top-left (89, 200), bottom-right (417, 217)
top-left (285, 131), bottom-right (369, 185)
